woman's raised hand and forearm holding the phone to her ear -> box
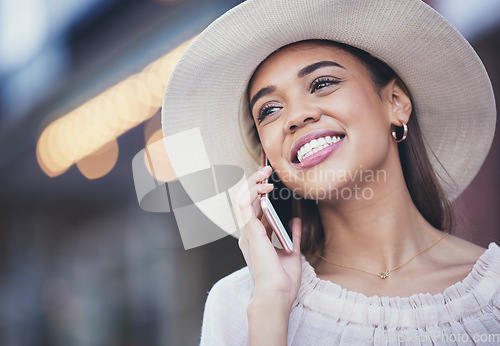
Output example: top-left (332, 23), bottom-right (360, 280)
top-left (238, 166), bottom-right (302, 345)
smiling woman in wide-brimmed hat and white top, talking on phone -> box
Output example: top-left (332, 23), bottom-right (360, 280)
top-left (163, 0), bottom-right (500, 345)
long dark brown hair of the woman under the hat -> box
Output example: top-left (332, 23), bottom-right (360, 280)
top-left (250, 40), bottom-right (454, 253)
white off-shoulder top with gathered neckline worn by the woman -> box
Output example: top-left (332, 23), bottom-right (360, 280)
top-left (201, 243), bottom-right (500, 346)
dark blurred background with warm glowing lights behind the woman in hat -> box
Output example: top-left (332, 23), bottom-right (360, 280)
top-left (0, 0), bottom-right (500, 346)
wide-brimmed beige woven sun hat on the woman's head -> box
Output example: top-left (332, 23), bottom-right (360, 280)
top-left (162, 0), bottom-right (496, 199)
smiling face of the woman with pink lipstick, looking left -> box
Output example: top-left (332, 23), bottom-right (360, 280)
top-left (249, 43), bottom-right (399, 199)
